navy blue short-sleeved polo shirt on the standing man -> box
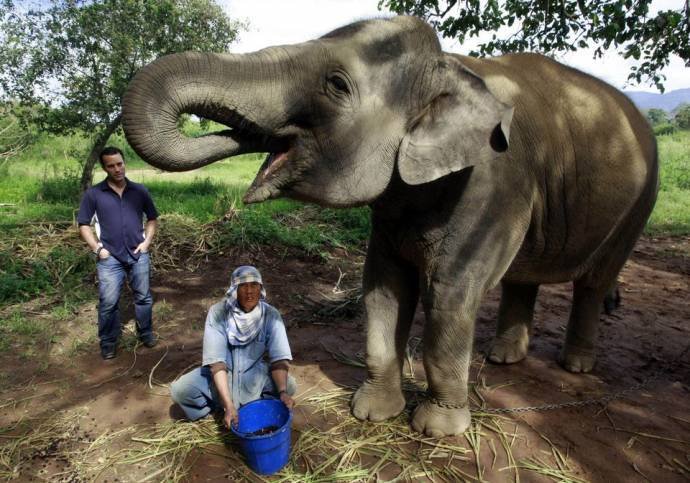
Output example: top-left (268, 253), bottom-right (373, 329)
top-left (77, 178), bottom-right (158, 263)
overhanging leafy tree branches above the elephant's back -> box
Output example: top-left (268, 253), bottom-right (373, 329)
top-left (379, 0), bottom-right (690, 91)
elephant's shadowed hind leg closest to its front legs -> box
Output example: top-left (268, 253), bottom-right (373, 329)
top-left (489, 281), bottom-right (539, 364)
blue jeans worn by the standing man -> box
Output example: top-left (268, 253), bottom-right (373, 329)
top-left (96, 253), bottom-right (153, 349)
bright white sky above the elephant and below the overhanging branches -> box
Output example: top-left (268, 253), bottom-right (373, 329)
top-left (219, 0), bottom-right (690, 92)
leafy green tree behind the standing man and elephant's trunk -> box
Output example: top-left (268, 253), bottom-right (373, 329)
top-left (0, 0), bottom-right (244, 188)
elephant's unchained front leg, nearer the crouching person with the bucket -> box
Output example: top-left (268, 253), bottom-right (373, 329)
top-left (351, 243), bottom-right (418, 421)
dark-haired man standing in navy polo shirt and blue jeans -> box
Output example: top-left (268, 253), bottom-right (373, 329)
top-left (77, 147), bottom-right (158, 359)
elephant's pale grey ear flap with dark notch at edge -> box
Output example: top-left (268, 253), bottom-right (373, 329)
top-left (398, 58), bottom-right (513, 185)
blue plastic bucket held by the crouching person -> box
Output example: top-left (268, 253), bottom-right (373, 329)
top-left (231, 399), bottom-right (292, 475)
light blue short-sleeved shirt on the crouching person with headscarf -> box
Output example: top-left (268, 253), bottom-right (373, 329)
top-left (202, 300), bottom-right (292, 406)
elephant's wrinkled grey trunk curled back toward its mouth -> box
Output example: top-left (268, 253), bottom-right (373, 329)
top-left (122, 48), bottom-right (289, 171)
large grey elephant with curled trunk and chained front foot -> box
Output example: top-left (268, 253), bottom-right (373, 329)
top-left (123, 16), bottom-right (658, 437)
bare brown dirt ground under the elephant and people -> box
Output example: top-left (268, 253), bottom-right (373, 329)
top-left (0, 237), bottom-right (690, 482)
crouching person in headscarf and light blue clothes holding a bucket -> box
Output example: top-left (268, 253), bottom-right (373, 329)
top-left (170, 266), bottom-right (296, 427)
